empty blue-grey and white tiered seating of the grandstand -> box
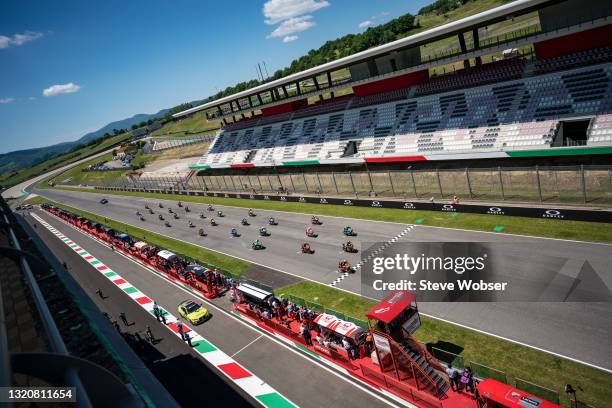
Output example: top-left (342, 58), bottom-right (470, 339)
top-left (198, 64), bottom-right (612, 165)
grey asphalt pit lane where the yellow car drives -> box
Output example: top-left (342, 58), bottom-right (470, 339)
top-left (27, 211), bottom-right (396, 407)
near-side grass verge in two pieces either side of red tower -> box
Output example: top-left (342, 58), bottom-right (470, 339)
top-left (275, 281), bottom-right (612, 408)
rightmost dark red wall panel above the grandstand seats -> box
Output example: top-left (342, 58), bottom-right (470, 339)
top-left (533, 24), bottom-right (612, 58)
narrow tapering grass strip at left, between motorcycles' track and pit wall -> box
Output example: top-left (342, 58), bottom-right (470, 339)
top-left (28, 196), bottom-right (250, 277)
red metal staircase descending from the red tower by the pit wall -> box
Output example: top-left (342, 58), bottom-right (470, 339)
top-left (377, 332), bottom-right (450, 399)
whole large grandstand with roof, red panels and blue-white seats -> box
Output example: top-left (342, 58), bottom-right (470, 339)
top-left (175, 0), bottom-right (612, 169)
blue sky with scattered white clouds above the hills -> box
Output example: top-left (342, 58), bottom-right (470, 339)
top-left (0, 0), bottom-right (431, 153)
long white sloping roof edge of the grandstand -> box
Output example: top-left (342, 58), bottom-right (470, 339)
top-left (172, 0), bottom-right (553, 118)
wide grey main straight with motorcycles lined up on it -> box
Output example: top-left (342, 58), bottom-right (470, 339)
top-left (35, 190), bottom-right (612, 370)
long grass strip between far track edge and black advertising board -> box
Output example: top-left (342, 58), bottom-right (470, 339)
top-left (51, 189), bottom-right (612, 243)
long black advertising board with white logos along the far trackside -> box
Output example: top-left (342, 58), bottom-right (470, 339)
top-left (98, 187), bottom-right (612, 223)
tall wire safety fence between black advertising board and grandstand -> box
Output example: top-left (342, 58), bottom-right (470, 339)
top-left (89, 165), bottom-right (612, 205)
